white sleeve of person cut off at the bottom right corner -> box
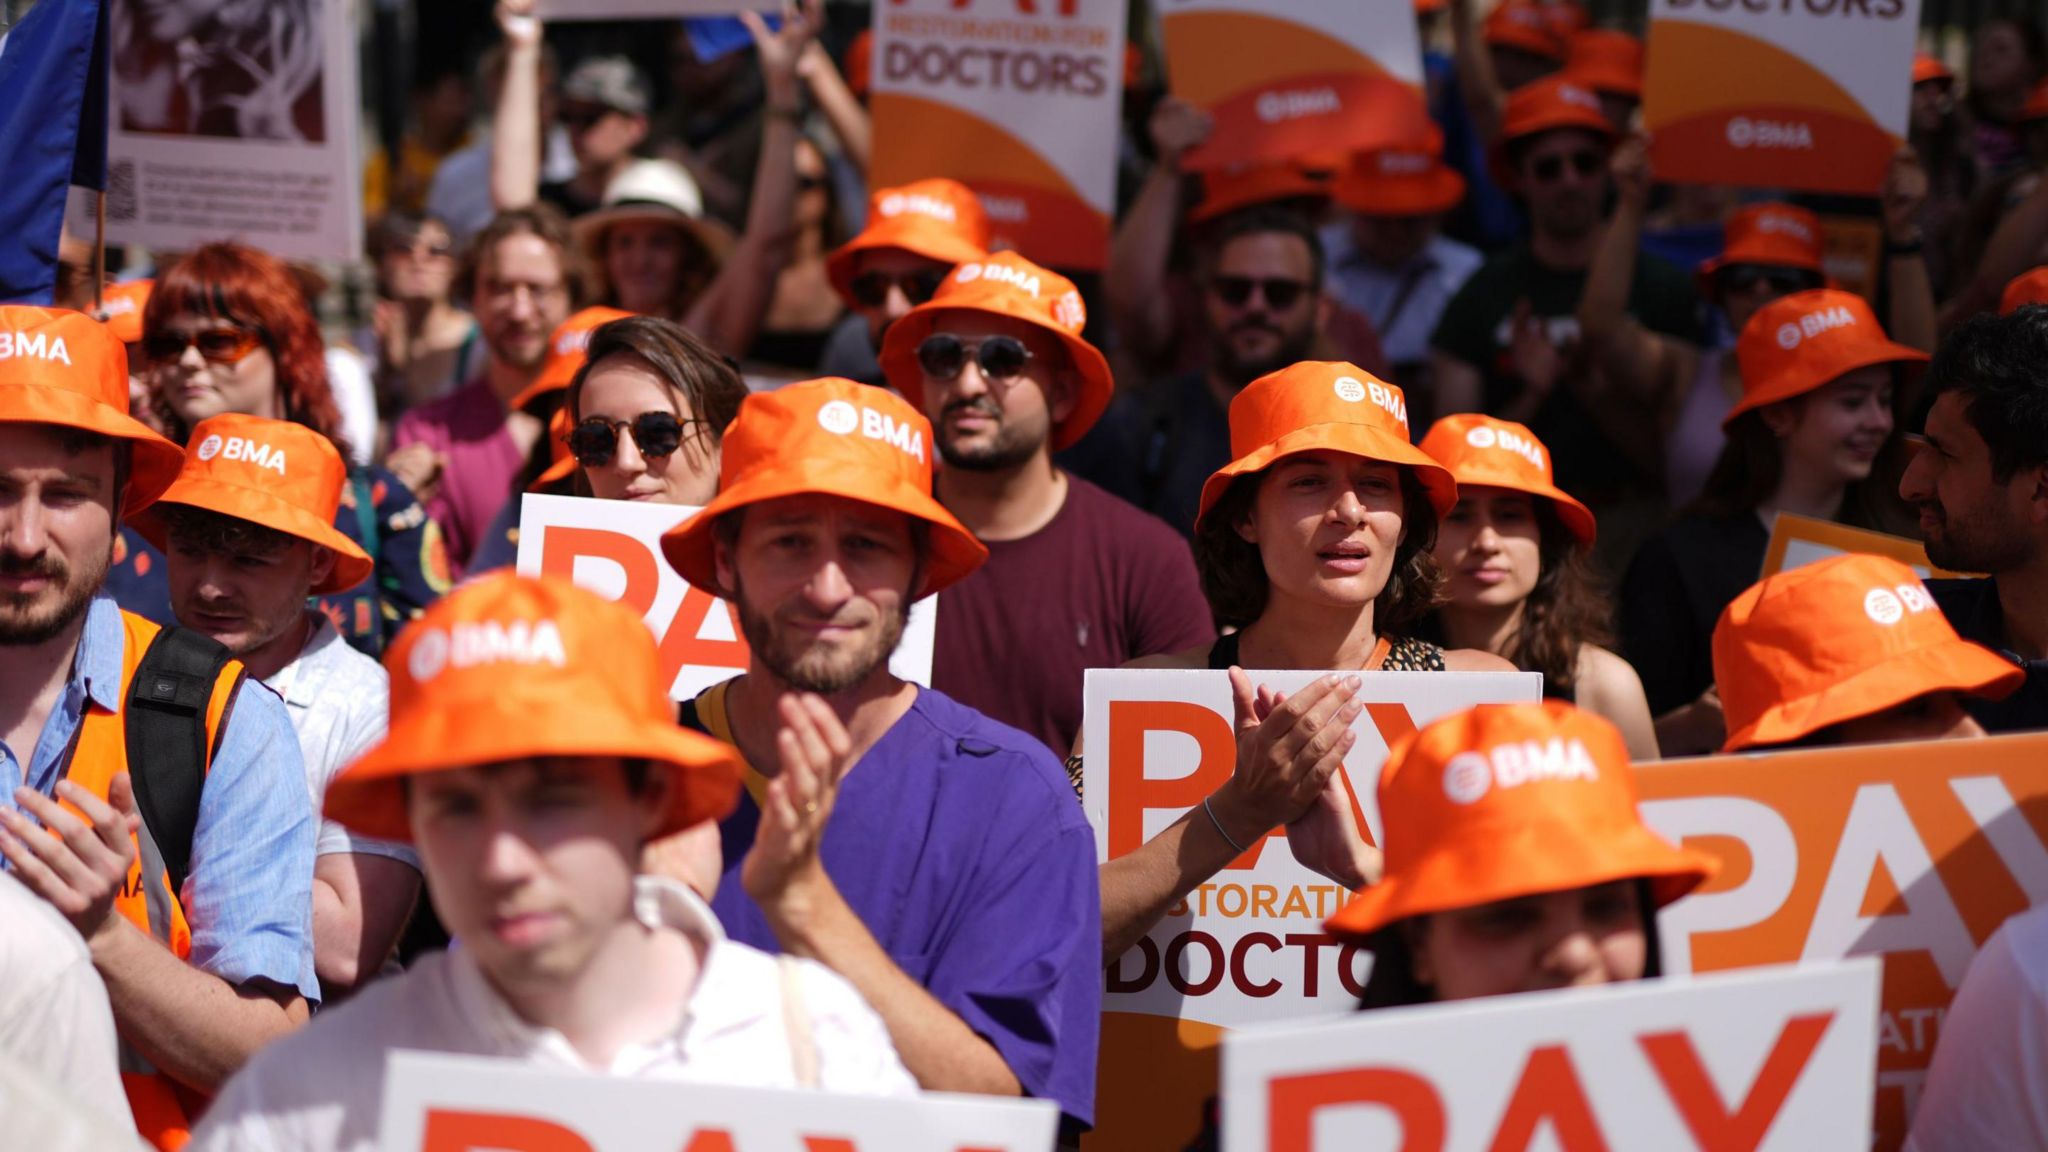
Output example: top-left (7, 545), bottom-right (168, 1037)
top-left (1907, 906), bottom-right (2048, 1152)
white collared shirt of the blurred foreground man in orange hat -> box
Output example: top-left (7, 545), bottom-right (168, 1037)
top-left (190, 877), bottom-right (918, 1152)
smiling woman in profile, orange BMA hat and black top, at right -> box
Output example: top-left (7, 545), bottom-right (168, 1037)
top-left (1620, 289), bottom-right (1927, 756)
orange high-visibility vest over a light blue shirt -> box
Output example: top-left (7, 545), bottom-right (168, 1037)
top-left (63, 613), bottom-right (242, 1152)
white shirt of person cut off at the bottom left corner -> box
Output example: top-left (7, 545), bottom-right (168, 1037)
top-left (0, 871), bottom-right (135, 1123)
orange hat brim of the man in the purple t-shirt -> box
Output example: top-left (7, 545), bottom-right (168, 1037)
top-left (662, 457), bottom-right (989, 596)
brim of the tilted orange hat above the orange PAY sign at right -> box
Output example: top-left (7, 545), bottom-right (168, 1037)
top-left (1720, 637), bottom-right (2028, 752)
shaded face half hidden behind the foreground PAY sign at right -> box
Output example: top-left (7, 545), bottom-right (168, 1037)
top-left (1403, 879), bottom-right (1649, 1000)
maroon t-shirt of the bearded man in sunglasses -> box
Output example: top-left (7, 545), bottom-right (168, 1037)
top-left (932, 474), bottom-right (1217, 758)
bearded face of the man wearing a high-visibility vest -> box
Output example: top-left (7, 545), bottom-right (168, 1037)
top-left (0, 422), bottom-right (121, 658)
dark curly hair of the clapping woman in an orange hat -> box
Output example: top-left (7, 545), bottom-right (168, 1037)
top-left (1194, 467), bottom-right (1444, 637)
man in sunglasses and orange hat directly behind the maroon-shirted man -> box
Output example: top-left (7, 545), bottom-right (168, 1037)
top-left (817, 178), bottom-right (989, 383)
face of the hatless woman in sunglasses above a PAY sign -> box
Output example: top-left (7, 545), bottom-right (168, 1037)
top-left (578, 353), bottom-right (719, 508)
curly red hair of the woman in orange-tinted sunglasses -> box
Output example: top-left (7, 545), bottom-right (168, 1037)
top-left (141, 242), bottom-right (348, 450)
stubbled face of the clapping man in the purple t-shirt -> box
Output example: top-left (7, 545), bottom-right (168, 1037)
top-left (717, 494), bottom-right (920, 695)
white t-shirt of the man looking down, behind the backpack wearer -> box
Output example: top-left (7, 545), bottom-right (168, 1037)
top-left (264, 613), bottom-right (420, 867)
